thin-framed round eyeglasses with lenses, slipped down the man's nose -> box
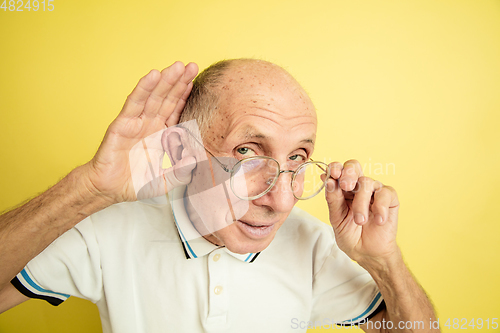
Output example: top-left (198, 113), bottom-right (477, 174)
top-left (182, 129), bottom-right (330, 200)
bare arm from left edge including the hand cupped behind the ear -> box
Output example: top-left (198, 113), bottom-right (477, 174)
top-left (0, 62), bottom-right (198, 304)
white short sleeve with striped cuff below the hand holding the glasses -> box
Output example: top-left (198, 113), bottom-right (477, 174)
top-left (311, 231), bottom-right (383, 325)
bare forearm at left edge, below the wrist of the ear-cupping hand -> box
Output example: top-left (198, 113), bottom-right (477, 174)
top-left (0, 166), bottom-right (111, 290)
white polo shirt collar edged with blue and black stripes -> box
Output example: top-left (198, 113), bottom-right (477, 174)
top-left (168, 186), bottom-right (260, 262)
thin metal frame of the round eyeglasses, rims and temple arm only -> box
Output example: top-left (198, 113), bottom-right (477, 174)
top-left (183, 127), bottom-right (330, 201)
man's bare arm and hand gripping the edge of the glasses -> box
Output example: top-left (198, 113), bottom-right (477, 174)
top-left (326, 160), bottom-right (439, 332)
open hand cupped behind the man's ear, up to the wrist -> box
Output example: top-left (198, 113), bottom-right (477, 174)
top-left (83, 62), bottom-right (198, 204)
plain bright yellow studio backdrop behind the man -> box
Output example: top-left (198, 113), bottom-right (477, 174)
top-left (0, 0), bottom-right (500, 333)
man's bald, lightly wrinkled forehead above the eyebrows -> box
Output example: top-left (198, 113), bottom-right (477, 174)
top-left (211, 62), bottom-right (316, 140)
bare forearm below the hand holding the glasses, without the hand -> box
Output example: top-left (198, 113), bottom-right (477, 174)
top-left (362, 249), bottom-right (439, 332)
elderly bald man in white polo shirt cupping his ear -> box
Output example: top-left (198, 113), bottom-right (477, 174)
top-left (0, 59), bottom-right (435, 332)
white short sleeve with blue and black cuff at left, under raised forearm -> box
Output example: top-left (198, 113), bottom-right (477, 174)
top-left (11, 217), bottom-right (103, 305)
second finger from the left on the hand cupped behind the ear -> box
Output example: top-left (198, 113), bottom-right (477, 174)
top-left (144, 61), bottom-right (185, 118)
